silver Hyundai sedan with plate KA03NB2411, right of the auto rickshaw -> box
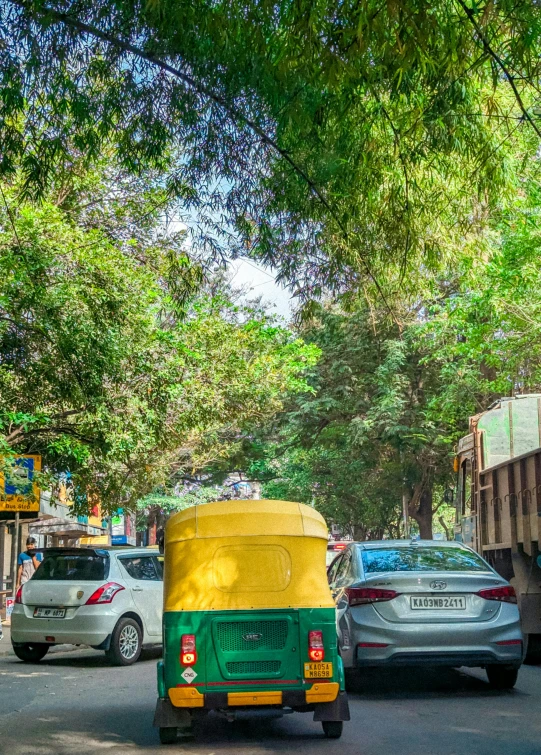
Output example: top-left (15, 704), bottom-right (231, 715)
top-left (328, 540), bottom-right (523, 689)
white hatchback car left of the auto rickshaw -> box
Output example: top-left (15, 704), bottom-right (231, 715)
top-left (11, 548), bottom-right (163, 666)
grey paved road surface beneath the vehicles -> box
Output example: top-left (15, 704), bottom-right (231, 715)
top-left (0, 650), bottom-right (541, 755)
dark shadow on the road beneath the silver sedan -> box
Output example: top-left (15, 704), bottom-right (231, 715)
top-left (348, 668), bottom-right (525, 700)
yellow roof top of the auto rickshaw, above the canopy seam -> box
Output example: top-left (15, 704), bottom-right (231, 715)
top-left (167, 499), bottom-right (327, 542)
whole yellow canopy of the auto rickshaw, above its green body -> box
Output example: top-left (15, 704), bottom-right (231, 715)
top-left (164, 500), bottom-right (334, 611)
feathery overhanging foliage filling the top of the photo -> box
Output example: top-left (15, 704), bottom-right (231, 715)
top-left (0, 0), bottom-right (541, 306)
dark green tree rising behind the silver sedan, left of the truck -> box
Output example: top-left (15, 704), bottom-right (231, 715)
top-left (258, 302), bottom-right (452, 538)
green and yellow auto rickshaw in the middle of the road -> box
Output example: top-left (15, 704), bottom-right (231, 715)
top-left (154, 500), bottom-right (349, 744)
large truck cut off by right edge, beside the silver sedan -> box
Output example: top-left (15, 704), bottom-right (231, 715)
top-left (455, 395), bottom-right (541, 662)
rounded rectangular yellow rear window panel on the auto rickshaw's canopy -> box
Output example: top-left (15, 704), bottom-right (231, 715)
top-left (212, 545), bottom-right (291, 593)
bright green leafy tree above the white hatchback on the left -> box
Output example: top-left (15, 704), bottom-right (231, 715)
top-left (0, 174), bottom-right (315, 510)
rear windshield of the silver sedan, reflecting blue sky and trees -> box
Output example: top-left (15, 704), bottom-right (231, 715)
top-left (361, 546), bottom-right (489, 574)
